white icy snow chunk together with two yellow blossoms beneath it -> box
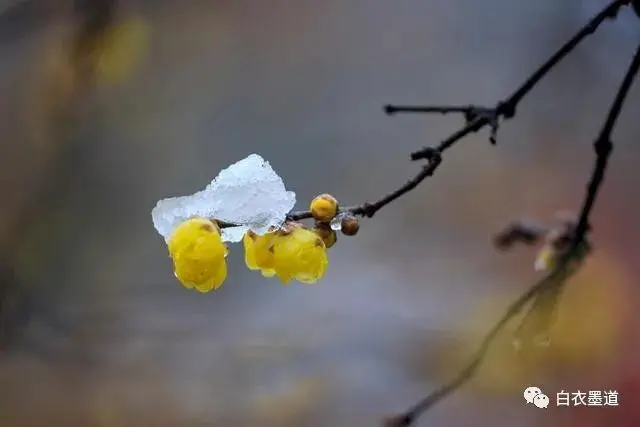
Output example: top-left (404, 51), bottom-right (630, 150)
top-left (151, 154), bottom-right (338, 292)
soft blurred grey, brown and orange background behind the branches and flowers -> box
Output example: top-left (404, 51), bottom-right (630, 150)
top-left (0, 0), bottom-right (640, 427)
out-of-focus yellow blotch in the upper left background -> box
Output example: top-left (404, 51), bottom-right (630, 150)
top-left (93, 19), bottom-right (148, 83)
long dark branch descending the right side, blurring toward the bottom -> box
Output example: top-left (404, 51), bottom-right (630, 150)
top-left (386, 38), bottom-right (640, 427)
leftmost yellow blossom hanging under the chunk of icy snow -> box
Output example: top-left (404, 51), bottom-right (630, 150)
top-left (167, 218), bottom-right (227, 292)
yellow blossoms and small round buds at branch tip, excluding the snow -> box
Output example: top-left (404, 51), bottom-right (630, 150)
top-left (162, 194), bottom-right (359, 292)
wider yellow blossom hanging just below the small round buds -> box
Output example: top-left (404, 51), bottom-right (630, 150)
top-left (243, 224), bottom-right (329, 284)
